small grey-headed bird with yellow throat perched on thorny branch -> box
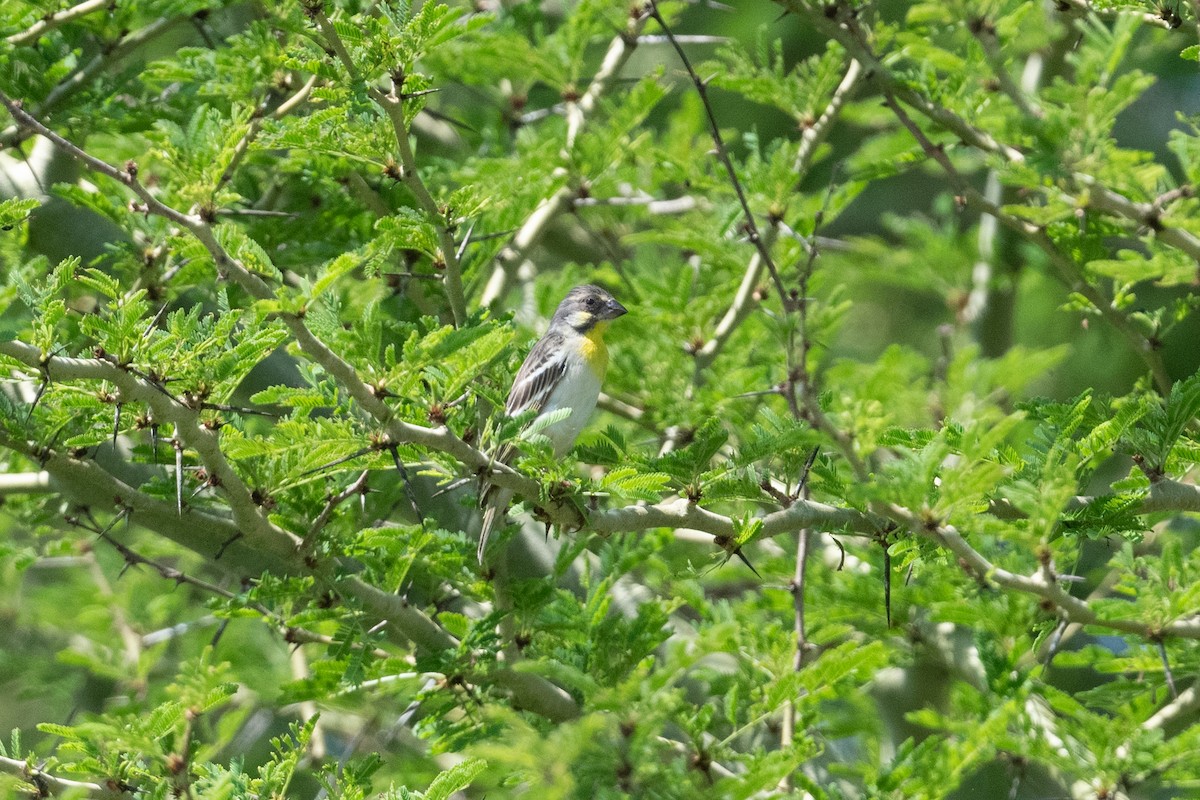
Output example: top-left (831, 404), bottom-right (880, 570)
top-left (478, 285), bottom-right (625, 564)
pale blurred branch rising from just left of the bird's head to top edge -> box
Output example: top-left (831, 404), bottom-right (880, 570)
top-left (479, 14), bottom-right (648, 308)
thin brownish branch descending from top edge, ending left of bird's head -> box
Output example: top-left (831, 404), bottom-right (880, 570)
top-left (312, 7), bottom-right (467, 326)
